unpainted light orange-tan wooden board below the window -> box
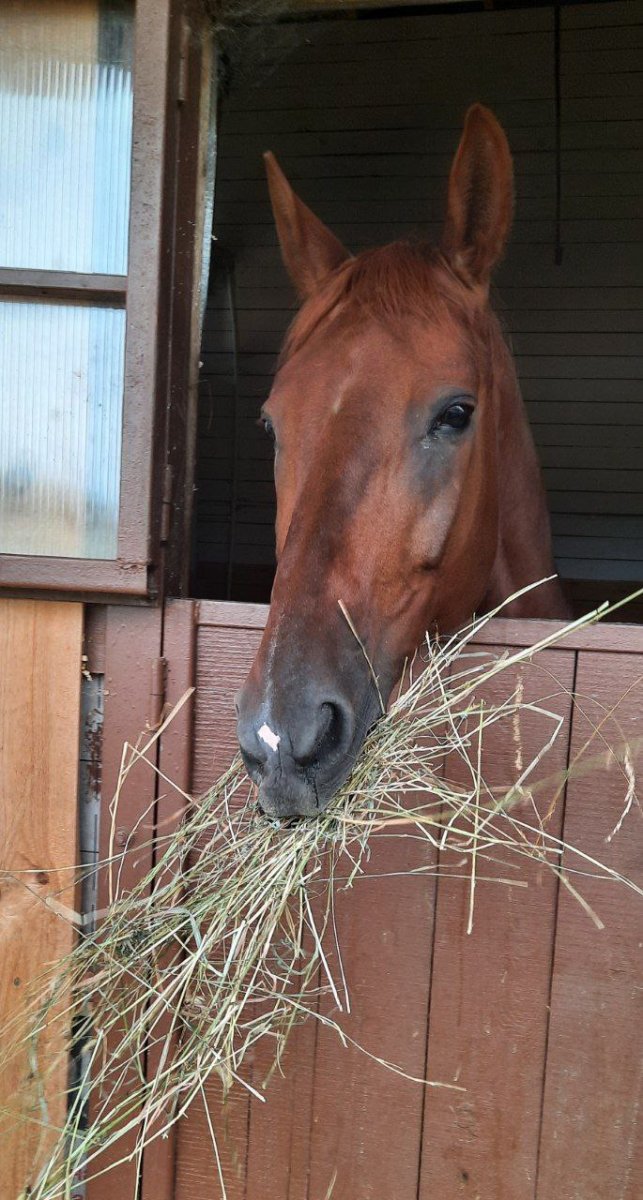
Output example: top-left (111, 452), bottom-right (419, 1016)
top-left (0, 600), bottom-right (83, 1200)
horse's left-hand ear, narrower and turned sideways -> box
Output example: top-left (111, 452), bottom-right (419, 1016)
top-left (264, 151), bottom-right (349, 300)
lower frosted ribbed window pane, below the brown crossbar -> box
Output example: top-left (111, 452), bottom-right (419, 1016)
top-left (0, 301), bottom-right (125, 558)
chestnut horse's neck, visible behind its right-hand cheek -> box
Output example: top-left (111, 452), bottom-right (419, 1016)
top-left (485, 342), bottom-right (569, 617)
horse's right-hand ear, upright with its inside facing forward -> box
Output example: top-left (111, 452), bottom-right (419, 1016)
top-left (441, 104), bottom-right (513, 286)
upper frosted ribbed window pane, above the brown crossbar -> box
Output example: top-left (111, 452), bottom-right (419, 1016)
top-left (0, 0), bottom-right (133, 275)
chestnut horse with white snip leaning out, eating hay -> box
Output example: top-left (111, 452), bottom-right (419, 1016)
top-left (236, 104), bottom-right (566, 818)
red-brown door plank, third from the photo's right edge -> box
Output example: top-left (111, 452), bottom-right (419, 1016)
top-left (310, 835), bottom-right (436, 1200)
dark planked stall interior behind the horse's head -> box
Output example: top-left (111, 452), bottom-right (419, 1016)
top-left (194, 0), bottom-right (643, 598)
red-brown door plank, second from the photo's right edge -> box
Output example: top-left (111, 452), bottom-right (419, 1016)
top-left (417, 647), bottom-right (575, 1200)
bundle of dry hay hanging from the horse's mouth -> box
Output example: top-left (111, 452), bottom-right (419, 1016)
top-left (0, 585), bottom-right (643, 1200)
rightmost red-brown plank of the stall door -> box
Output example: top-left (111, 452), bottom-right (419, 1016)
top-left (537, 650), bottom-right (643, 1200)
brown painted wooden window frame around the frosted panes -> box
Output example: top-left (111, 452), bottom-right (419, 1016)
top-left (0, 0), bottom-right (181, 599)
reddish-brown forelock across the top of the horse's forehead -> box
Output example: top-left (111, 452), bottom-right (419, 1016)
top-left (281, 241), bottom-right (475, 362)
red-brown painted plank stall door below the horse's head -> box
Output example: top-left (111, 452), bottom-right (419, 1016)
top-left (95, 601), bottom-right (643, 1200)
